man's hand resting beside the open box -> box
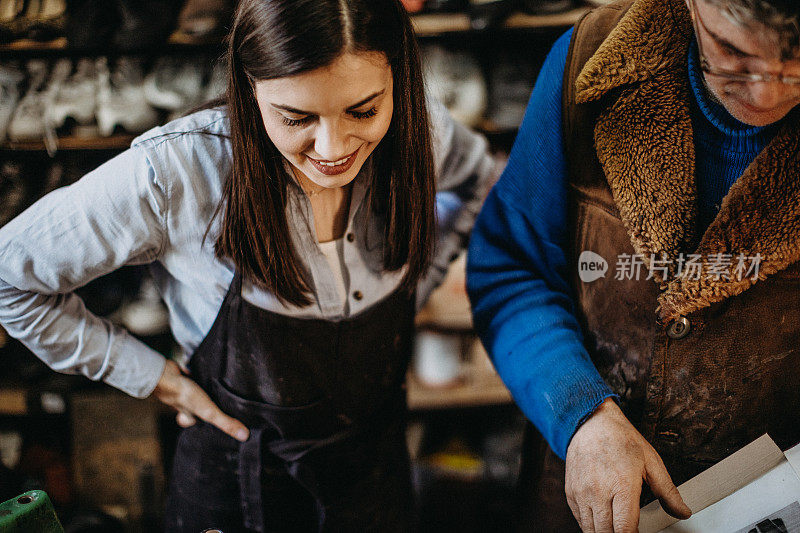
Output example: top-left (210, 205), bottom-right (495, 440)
top-left (566, 398), bottom-right (692, 533)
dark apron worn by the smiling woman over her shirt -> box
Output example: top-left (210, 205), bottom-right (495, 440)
top-left (160, 272), bottom-right (414, 533)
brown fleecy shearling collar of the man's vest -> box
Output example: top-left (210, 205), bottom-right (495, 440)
top-left (575, 0), bottom-right (800, 322)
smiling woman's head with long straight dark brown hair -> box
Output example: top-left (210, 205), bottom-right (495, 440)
top-left (217, 0), bottom-right (434, 304)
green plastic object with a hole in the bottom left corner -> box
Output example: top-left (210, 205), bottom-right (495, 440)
top-left (0, 490), bottom-right (64, 533)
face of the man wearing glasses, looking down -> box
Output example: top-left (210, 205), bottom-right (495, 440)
top-left (688, 0), bottom-right (800, 126)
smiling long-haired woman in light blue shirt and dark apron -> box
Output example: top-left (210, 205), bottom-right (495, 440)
top-left (0, 0), bottom-right (495, 533)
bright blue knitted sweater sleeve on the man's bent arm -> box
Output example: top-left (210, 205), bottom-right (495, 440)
top-left (467, 30), bottom-right (613, 458)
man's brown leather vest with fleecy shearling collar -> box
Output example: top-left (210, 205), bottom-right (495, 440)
top-left (563, 0), bottom-right (800, 483)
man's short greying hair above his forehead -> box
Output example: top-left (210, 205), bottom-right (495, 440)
top-left (706, 0), bottom-right (800, 59)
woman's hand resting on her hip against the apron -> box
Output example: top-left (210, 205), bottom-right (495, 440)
top-left (153, 361), bottom-right (250, 442)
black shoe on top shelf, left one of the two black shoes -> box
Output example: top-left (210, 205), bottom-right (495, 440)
top-left (66, 0), bottom-right (119, 51)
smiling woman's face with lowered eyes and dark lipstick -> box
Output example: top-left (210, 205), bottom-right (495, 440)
top-left (255, 52), bottom-right (394, 188)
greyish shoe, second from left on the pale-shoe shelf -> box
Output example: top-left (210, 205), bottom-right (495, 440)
top-left (8, 59), bottom-right (53, 141)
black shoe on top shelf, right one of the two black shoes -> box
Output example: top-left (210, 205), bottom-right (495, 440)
top-left (112, 0), bottom-right (181, 52)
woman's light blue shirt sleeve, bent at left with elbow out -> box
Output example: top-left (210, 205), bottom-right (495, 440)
top-left (0, 143), bottom-right (167, 397)
